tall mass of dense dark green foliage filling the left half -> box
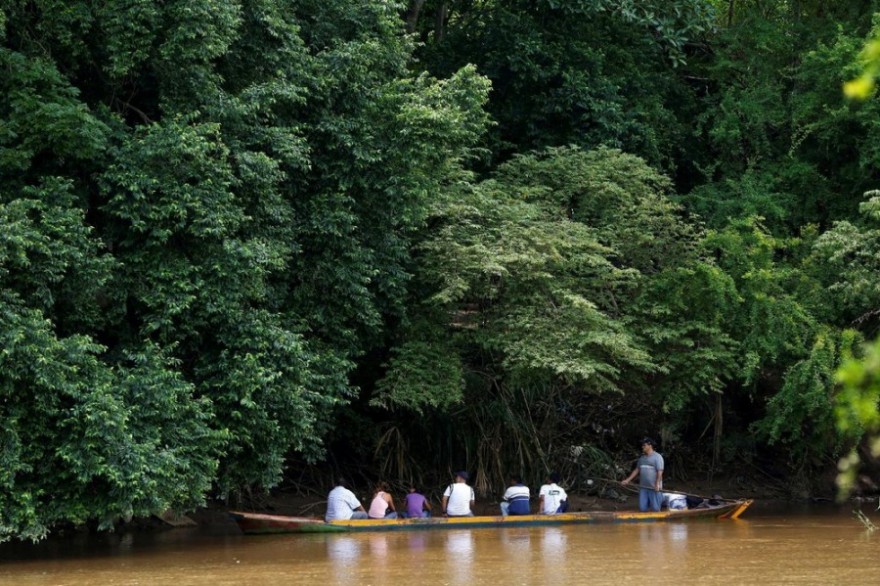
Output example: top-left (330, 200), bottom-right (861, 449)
top-left (0, 0), bottom-right (486, 537)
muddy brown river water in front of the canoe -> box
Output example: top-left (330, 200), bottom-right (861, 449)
top-left (0, 507), bottom-right (880, 586)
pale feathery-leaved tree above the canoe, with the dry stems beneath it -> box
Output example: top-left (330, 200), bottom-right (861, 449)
top-left (373, 146), bottom-right (654, 480)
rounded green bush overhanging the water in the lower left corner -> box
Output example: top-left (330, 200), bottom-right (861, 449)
top-left (0, 294), bottom-right (221, 539)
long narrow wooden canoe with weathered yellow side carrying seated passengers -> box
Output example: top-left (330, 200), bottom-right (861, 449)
top-left (229, 500), bottom-right (752, 534)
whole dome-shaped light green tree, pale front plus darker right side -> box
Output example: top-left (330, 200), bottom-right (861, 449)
top-left (373, 148), bottom-right (756, 480)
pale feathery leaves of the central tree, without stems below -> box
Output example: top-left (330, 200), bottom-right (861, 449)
top-left (379, 151), bottom-right (664, 409)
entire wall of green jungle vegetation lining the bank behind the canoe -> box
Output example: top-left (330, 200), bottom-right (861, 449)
top-left (0, 0), bottom-right (880, 540)
